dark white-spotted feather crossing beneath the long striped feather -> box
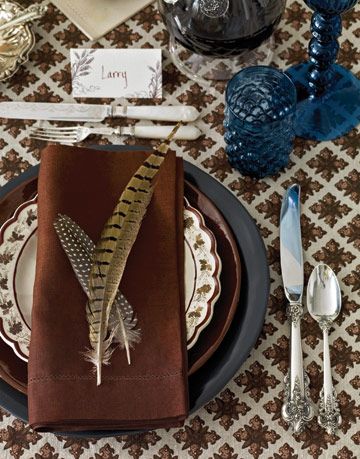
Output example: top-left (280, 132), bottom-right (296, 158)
top-left (54, 214), bottom-right (141, 363)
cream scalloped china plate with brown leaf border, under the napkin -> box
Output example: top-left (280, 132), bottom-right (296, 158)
top-left (0, 197), bottom-right (221, 361)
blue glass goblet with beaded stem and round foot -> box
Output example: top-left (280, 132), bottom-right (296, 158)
top-left (287, 0), bottom-right (360, 140)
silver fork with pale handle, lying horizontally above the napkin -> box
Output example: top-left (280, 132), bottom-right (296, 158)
top-left (29, 125), bottom-right (202, 143)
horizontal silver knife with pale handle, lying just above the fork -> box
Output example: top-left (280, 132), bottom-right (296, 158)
top-left (0, 102), bottom-right (200, 123)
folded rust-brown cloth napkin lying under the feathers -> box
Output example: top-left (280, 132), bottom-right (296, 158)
top-left (28, 146), bottom-right (188, 431)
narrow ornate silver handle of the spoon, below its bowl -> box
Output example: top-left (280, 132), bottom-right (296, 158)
top-left (318, 324), bottom-right (341, 435)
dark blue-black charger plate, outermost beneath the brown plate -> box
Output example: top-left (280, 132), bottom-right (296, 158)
top-left (0, 156), bottom-right (270, 437)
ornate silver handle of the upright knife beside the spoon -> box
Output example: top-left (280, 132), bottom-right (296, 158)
top-left (282, 302), bottom-right (314, 433)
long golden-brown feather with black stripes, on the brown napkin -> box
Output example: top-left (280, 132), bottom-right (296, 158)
top-left (86, 123), bottom-right (180, 385)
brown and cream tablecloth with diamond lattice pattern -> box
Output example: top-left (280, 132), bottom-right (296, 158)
top-left (0, 0), bottom-right (360, 459)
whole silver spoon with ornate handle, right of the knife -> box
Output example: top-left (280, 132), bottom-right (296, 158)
top-left (307, 263), bottom-right (341, 434)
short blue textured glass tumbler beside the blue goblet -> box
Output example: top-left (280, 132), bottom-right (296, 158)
top-left (224, 66), bottom-right (296, 178)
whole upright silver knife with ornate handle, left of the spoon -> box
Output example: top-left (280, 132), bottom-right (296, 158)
top-left (280, 184), bottom-right (314, 433)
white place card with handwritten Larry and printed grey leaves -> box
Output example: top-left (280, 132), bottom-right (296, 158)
top-left (70, 49), bottom-right (162, 99)
